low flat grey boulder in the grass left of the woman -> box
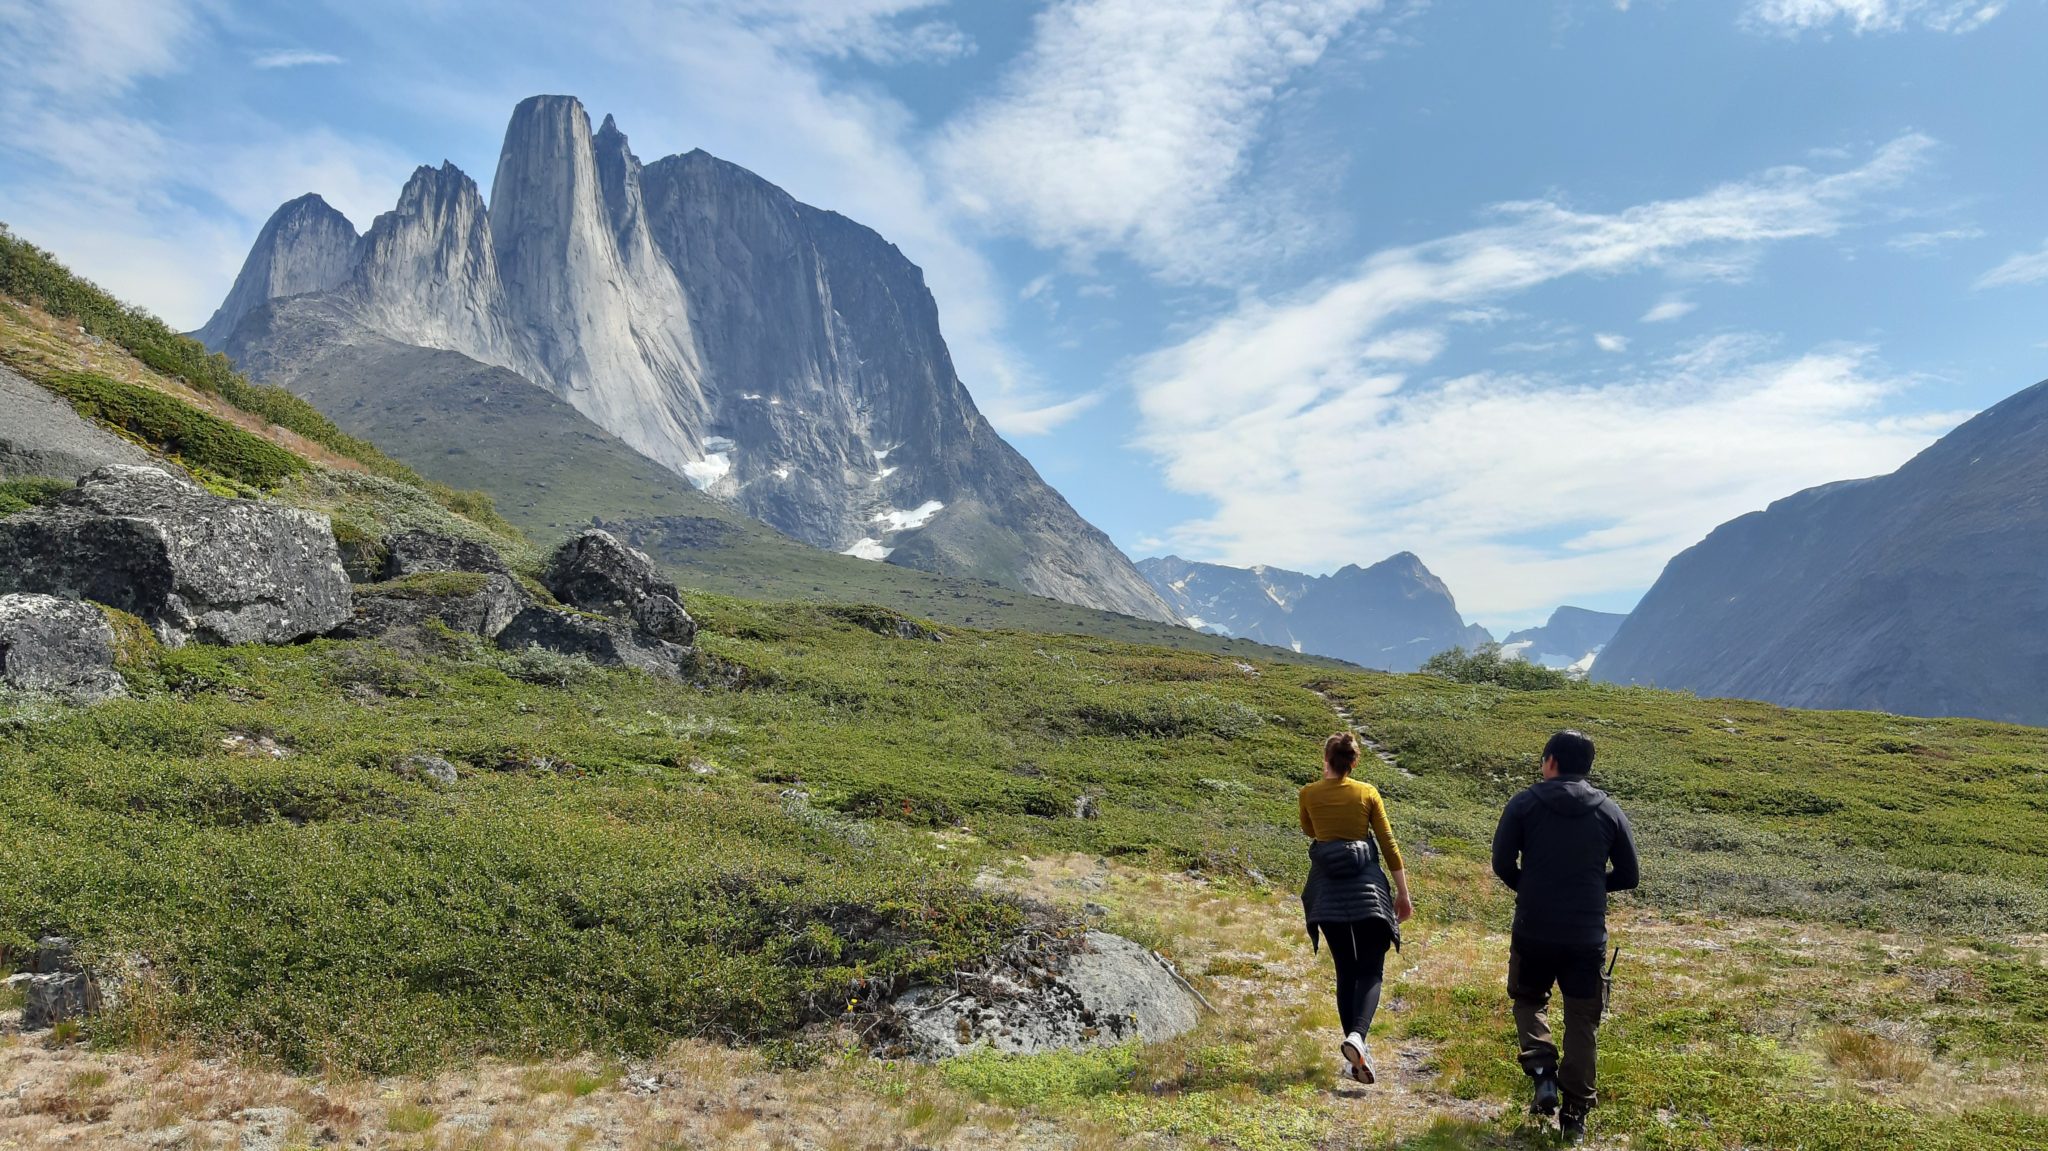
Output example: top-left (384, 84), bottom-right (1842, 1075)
top-left (883, 932), bottom-right (1200, 1059)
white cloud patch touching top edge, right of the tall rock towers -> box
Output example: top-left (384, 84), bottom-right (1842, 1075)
top-left (936, 0), bottom-right (1380, 279)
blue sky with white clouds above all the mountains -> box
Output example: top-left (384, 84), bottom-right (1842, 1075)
top-left (0, 0), bottom-right (2048, 627)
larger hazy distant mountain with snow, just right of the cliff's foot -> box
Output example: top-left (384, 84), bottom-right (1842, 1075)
top-left (1139, 551), bottom-right (1493, 672)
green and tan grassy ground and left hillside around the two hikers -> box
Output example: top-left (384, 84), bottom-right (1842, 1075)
top-left (12, 212), bottom-right (2048, 1151)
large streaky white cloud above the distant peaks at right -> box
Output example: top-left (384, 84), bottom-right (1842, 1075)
top-left (1133, 135), bottom-right (1954, 614)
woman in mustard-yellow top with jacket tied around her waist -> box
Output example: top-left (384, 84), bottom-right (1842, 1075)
top-left (1300, 731), bottom-right (1415, 1083)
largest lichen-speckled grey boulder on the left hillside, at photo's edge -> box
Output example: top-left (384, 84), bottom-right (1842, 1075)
top-left (0, 465), bottom-right (350, 647)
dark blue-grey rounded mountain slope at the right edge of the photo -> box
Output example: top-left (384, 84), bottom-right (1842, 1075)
top-left (1593, 383), bottom-right (2048, 725)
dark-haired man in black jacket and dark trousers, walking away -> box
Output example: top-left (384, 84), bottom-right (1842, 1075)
top-left (1493, 731), bottom-right (1640, 1143)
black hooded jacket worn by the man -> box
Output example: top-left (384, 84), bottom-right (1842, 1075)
top-left (1493, 776), bottom-right (1640, 946)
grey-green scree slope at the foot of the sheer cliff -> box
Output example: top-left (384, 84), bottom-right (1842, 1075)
top-left (264, 323), bottom-right (1333, 666)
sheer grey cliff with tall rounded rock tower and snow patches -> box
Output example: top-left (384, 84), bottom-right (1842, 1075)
top-left (201, 96), bottom-right (1174, 619)
